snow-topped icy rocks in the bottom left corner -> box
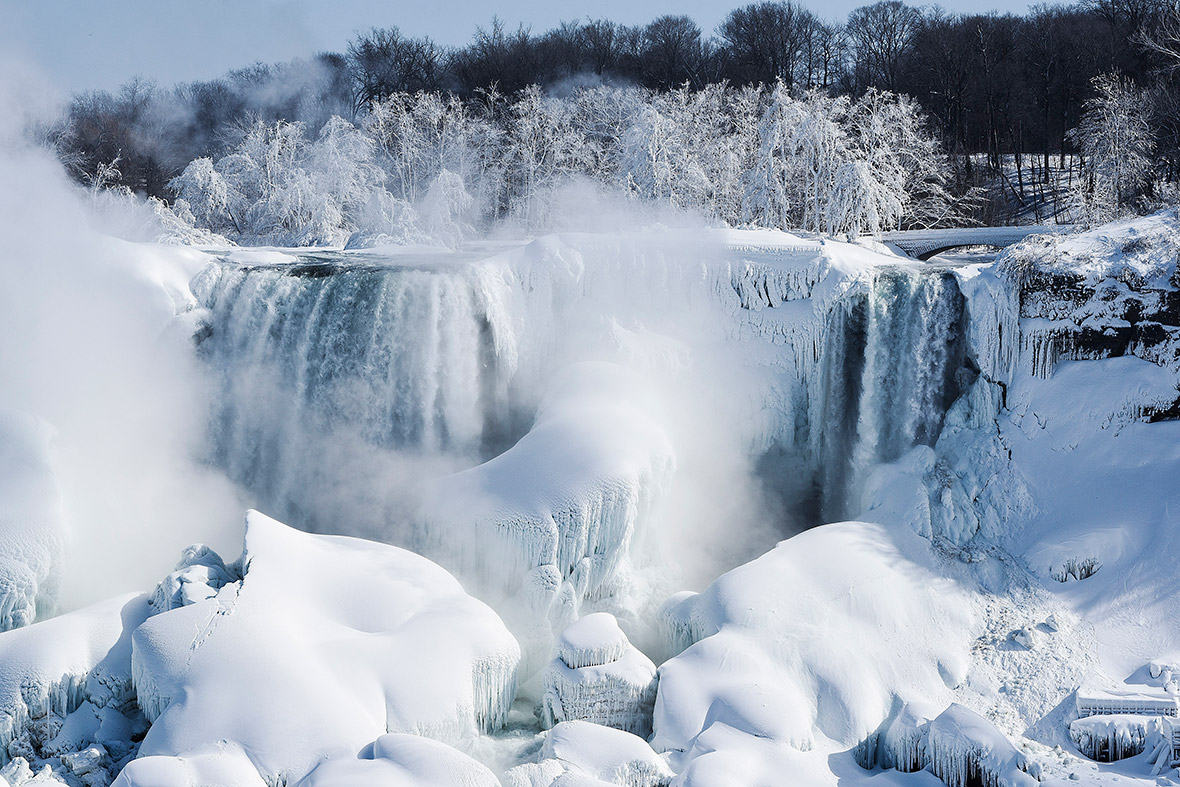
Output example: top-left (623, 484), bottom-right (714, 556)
top-left (0, 595), bottom-right (151, 785)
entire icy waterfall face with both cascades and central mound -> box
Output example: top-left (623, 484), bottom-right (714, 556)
top-left (192, 231), bottom-right (990, 674)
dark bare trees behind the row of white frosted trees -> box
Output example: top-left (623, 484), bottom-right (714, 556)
top-left (46, 0), bottom-right (1180, 237)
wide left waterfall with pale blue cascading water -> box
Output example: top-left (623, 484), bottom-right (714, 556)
top-left (192, 261), bottom-right (527, 539)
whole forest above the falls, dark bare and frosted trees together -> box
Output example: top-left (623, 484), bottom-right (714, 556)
top-left (50, 0), bottom-right (1180, 244)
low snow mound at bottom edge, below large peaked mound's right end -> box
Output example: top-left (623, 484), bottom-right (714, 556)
top-left (299, 734), bottom-right (500, 787)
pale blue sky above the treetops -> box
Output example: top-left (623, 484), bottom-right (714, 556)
top-left (0, 0), bottom-right (1057, 92)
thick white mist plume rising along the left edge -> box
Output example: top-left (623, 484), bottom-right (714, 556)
top-left (0, 58), bottom-right (240, 606)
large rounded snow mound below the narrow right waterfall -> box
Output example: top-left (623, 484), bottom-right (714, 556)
top-left (653, 523), bottom-right (975, 785)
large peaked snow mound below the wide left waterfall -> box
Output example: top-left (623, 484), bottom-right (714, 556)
top-left (131, 511), bottom-right (519, 783)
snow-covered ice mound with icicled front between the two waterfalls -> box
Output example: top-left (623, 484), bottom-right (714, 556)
top-left (419, 362), bottom-right (675, 670)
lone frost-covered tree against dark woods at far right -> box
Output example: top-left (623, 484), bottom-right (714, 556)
top-left (1070, 73), bottom-right (1155, 222)
